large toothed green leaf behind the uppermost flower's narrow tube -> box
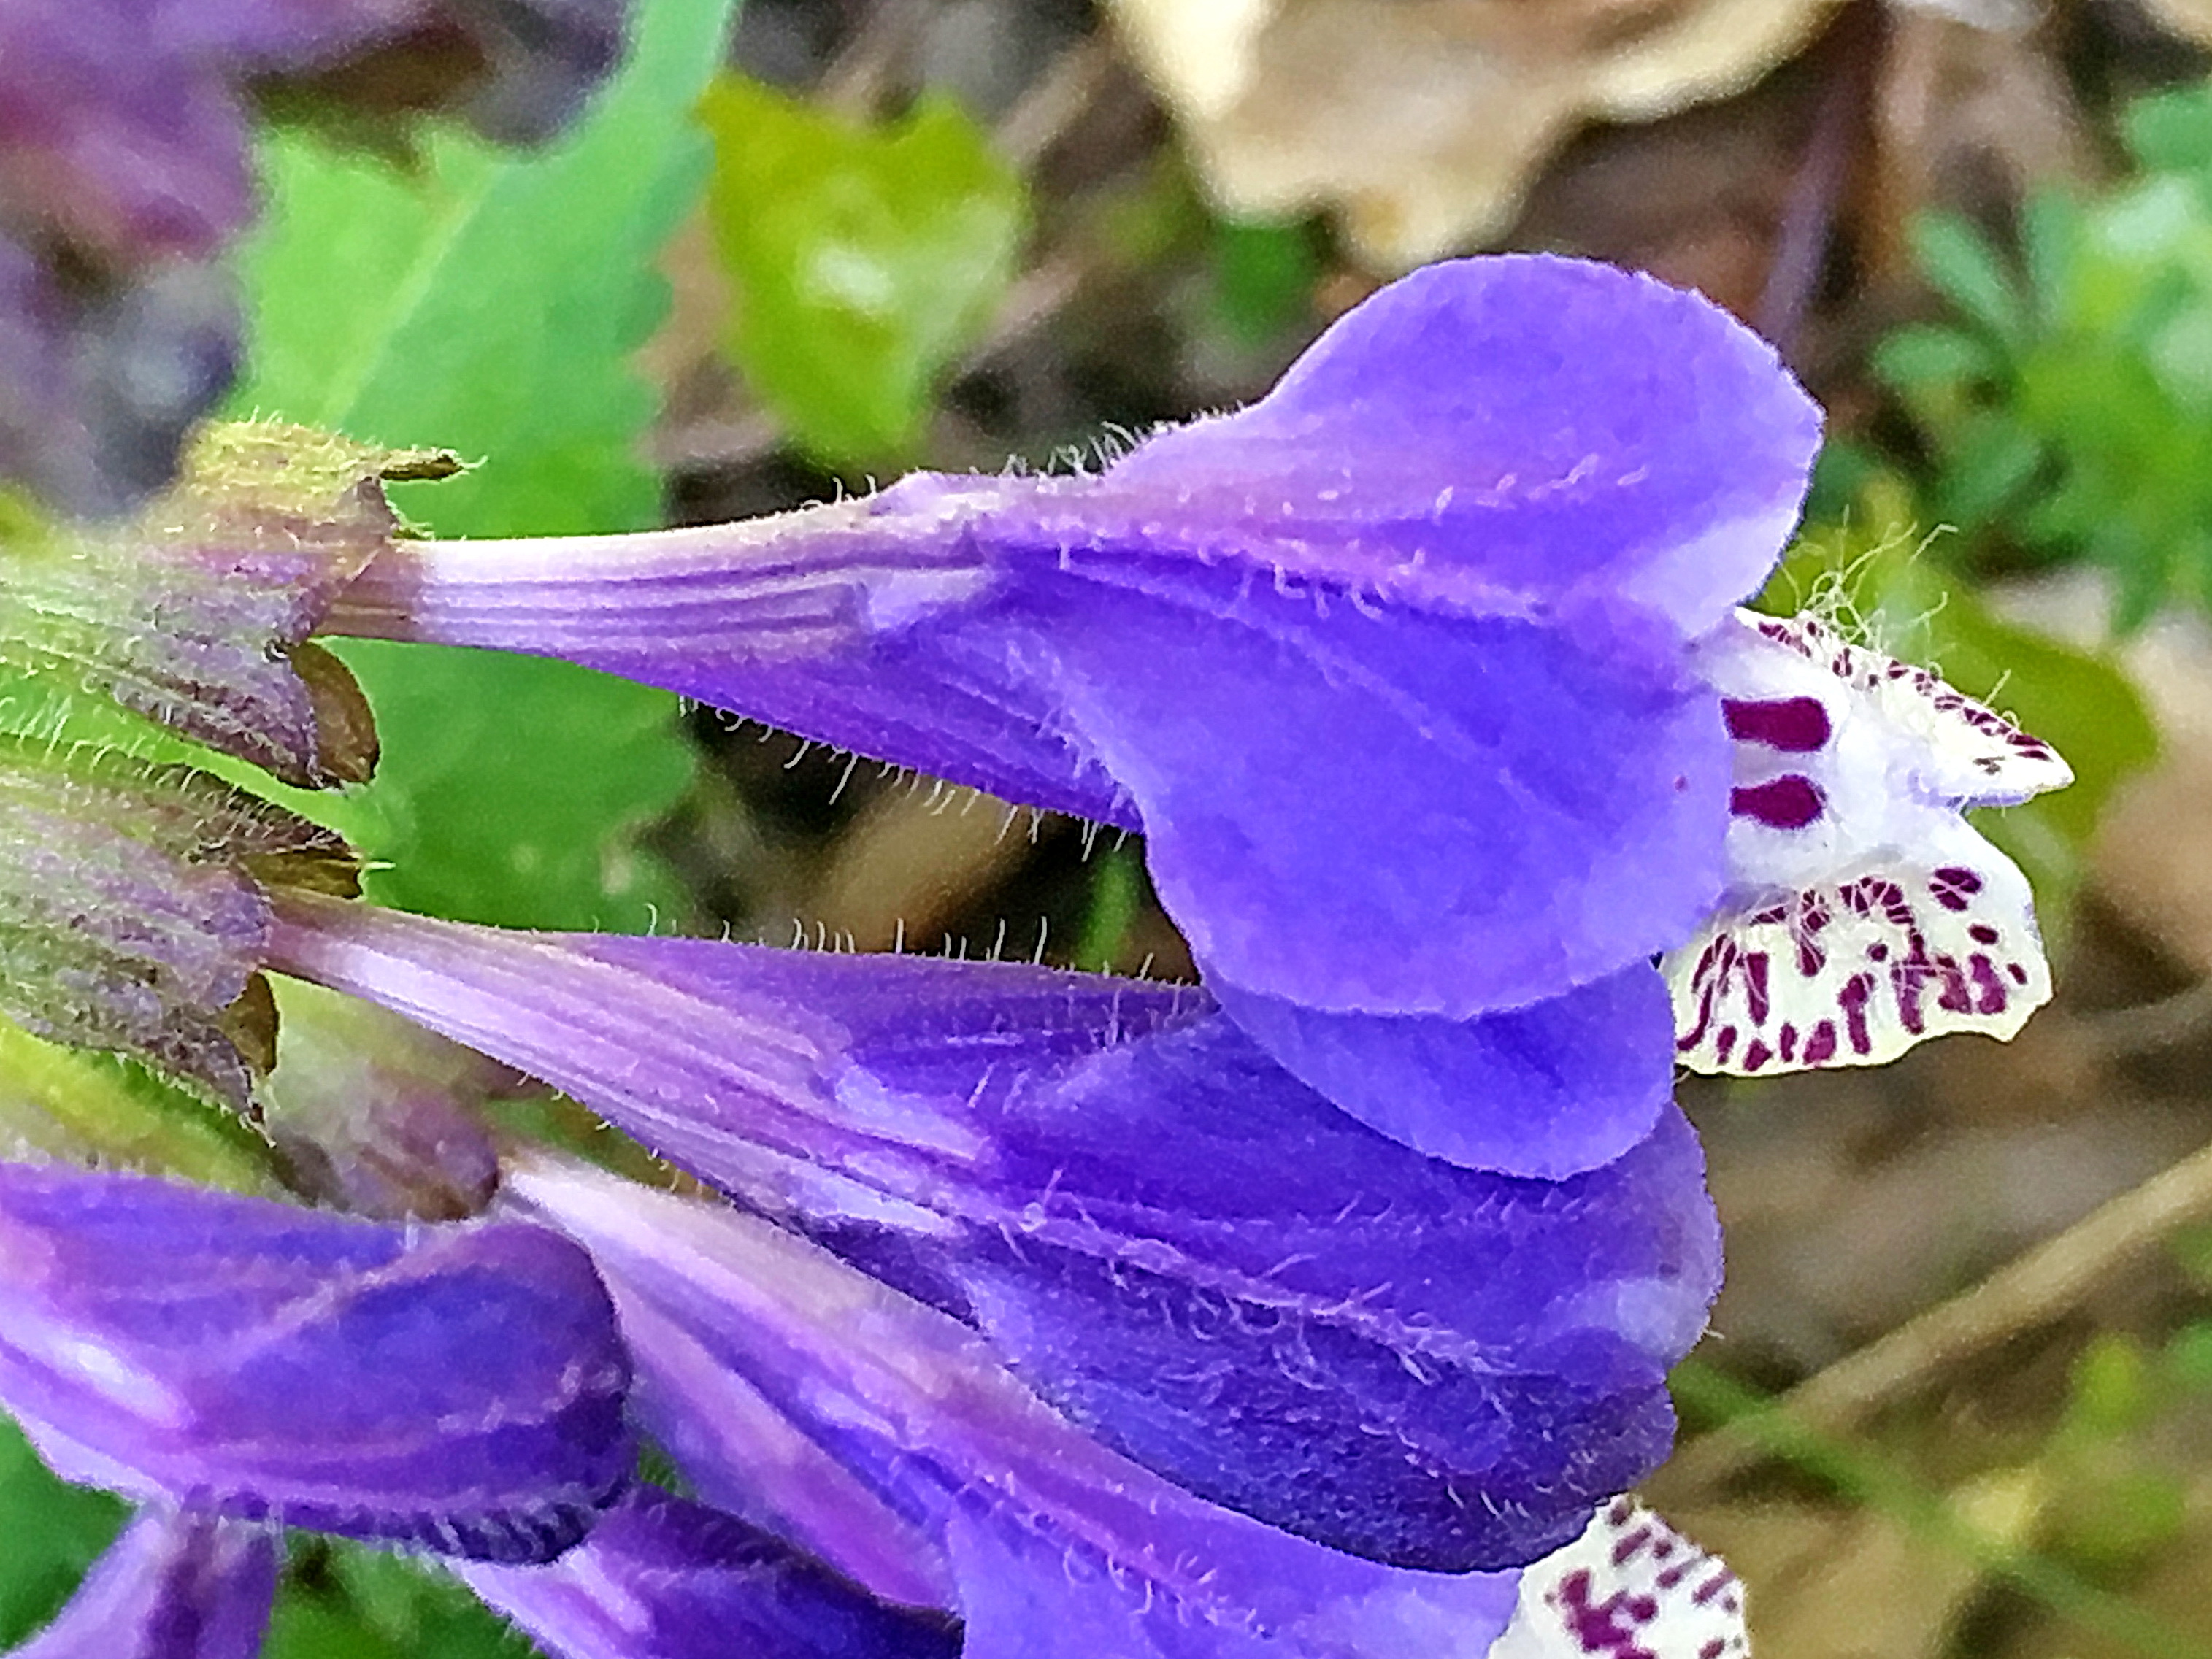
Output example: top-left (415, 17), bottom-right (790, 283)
top-left (239, 0), bottom-right (734, 929)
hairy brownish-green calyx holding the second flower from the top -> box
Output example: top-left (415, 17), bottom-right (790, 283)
top-left (0, 739), bottom-right (358, 1108)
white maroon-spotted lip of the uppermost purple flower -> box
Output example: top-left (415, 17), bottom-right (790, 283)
top-left (1662, 612), bottom-right (2073, 1075)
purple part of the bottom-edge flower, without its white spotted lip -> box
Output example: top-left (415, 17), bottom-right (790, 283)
top-left (511, 1159), bottom-right (1516, 1659)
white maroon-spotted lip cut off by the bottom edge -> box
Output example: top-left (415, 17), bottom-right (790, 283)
top-left (1489, 1498), bottom-right (1752, 1659)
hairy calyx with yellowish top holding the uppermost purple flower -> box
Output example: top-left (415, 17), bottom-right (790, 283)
top-left (0, 423), bottom-right (460, 788)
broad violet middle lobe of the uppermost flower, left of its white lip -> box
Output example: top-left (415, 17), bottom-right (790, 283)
top-left (1013, 586), bottom-right (1727, 1017)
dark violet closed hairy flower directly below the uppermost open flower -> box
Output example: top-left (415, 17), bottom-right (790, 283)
top-left (270, 898), bottom-right (1718, 1571)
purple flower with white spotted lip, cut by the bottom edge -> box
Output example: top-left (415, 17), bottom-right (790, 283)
top-left (493, 1157), bottom-right (1748, 1659)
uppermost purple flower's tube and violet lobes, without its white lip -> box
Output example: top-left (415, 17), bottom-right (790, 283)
top-left (312, 257), bottom-right (1819, 1177)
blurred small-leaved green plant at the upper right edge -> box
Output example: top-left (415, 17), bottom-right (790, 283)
top-left (1873, 76), bottom-right (2212, 628)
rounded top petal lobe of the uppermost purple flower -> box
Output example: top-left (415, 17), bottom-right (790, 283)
top-left (1026, 255), bottom-right (1821, 635)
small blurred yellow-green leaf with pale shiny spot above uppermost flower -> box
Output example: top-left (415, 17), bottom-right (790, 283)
top-left (699, 75), bottom-right (1029, 464)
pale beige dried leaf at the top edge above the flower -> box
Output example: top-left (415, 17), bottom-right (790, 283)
top-left (1113, 0), bottom-right (1838, 270)
